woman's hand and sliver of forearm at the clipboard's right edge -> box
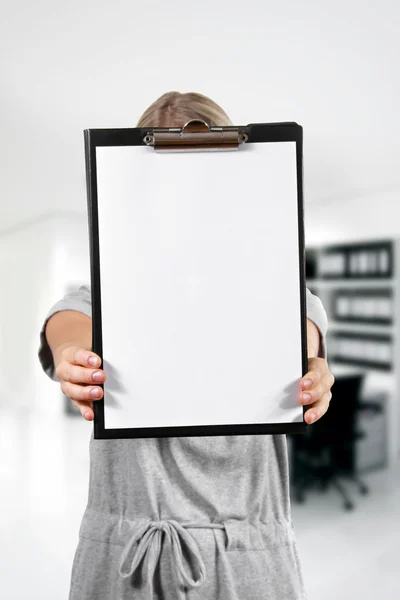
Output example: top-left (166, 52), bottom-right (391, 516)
top-left (299, 319), bottom-right (335, 424)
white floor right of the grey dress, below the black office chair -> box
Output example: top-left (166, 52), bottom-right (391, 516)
top-left (292, 463), bottom-right (400, 600)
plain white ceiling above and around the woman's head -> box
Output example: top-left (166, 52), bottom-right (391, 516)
top-left (0, 0), bottom-right (400, 231)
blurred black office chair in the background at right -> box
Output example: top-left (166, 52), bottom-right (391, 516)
top-left (291, 374), bottom-right (381, 510)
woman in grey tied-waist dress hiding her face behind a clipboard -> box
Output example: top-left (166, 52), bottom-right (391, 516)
top-left (39, 92), bottom-right (334, 600)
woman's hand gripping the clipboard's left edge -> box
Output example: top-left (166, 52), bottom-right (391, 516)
top-left (56, 346), bottom-right (106, 421)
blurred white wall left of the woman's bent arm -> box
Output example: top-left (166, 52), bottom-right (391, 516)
top-left (0, 214), bottom-right (90, 414)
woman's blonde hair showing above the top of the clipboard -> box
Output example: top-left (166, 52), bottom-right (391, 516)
top-left (136, 92), bottom-right (233, 127)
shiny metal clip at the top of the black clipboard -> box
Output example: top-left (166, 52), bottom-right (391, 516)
top-left (143, 119), bottom-right (248, 152)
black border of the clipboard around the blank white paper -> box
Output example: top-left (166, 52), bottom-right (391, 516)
top-left (84, 122), bottom-right (309, 439)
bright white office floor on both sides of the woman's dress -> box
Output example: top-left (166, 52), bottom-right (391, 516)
top-left (0, 404), bottom-right (400, 600)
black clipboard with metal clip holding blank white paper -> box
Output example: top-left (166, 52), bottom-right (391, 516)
top-left (84, 120), bottom-right (308, 439)
